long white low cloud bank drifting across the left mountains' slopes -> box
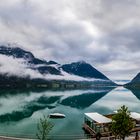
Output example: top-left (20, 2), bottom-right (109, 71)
top-left (0, 55), bottom-right (105, 81)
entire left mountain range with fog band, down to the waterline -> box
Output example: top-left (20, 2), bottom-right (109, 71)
top-left (0, 45), bottom-right (116, 88)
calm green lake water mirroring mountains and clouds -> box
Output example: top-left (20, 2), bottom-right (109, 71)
top-left (0, 87), bottom-right (140, 140)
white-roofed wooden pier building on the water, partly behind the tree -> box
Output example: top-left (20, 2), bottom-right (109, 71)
top-left (83, 112), bottom-right (140, 140)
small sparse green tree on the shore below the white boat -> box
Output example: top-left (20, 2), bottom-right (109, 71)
top-left (37, 116), bottom-right (53, 140)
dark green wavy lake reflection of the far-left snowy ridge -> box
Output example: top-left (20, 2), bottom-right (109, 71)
top-left (0, 96), bottom-right (60, 122)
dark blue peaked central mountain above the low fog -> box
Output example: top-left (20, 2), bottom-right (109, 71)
top-left (61, 61), bottom-right (109, 80)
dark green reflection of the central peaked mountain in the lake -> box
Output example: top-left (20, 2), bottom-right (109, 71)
top-left (61, 88), bottom-right (113, 109)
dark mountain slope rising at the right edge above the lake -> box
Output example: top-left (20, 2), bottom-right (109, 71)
top-left (124, 73), bottom-right (140, 89)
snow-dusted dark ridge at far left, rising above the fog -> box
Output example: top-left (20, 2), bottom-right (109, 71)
top-left (0, 46), bottom-right (61, 75)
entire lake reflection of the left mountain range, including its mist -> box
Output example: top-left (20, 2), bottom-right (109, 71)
top-left (0, 87), bottom-right (113, 123)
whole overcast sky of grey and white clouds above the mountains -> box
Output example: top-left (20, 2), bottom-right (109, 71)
top-left (0, 0), bottom-right (140, 80)
